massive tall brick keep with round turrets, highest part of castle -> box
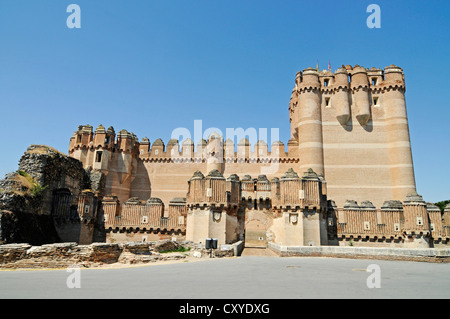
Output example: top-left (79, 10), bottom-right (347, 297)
top-left (288, 65), bottom-right (415, 207)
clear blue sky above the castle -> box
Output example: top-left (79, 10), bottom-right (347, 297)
top-left (0, 0), bottom-right (450, 202)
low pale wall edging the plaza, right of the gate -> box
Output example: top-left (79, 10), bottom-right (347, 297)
top-left (269, 243), bottom-right (450, 263)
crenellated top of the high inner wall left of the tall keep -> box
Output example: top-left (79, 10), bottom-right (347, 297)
top-left (69, 125), bottom-right (306, 169)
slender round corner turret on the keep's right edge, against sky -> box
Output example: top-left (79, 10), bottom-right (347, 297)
top-left (382, 65), bottom-right (416, 200)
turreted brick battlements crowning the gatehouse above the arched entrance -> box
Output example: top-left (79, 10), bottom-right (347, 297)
top-left (186, 168), bottom-right (327, 210)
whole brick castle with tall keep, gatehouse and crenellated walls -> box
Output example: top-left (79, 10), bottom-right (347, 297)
top-left (59, 65), bottom-right (450, 247)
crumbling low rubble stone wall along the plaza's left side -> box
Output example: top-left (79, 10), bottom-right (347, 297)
top-left (0, 240), bottom-right (243, 269)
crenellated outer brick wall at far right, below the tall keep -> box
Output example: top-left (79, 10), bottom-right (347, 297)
top-left (331, 193), bottom-right (450, 247)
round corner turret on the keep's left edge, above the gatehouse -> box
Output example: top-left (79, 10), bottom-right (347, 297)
top-left (291, 68), bottom-right (324, 174)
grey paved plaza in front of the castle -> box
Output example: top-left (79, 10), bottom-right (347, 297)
top-left (0, 256), bottom-right (450, 299)
